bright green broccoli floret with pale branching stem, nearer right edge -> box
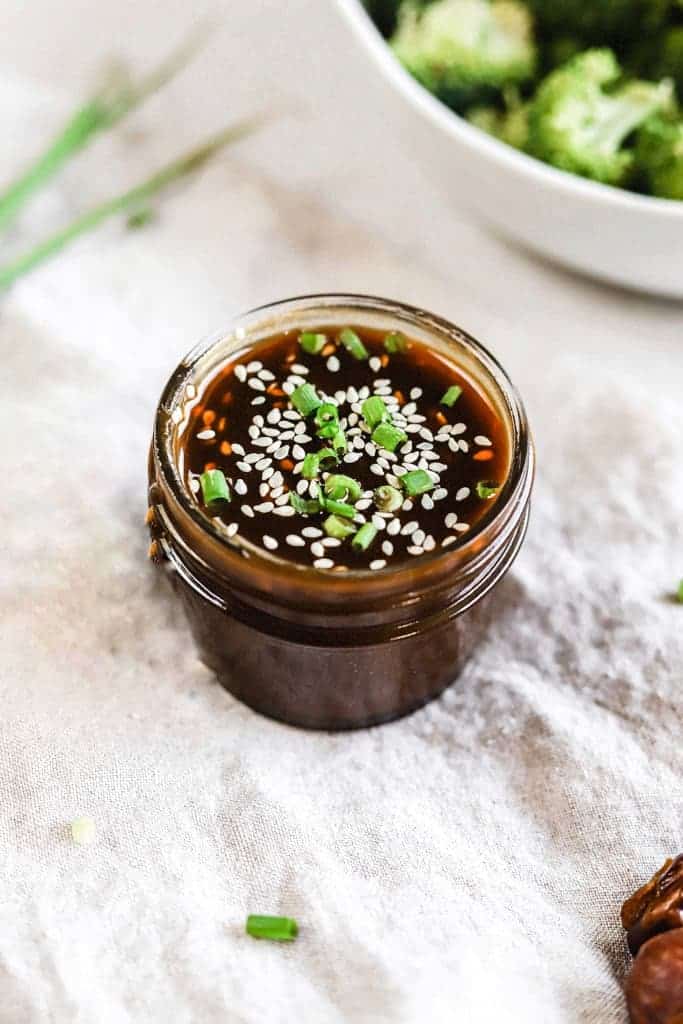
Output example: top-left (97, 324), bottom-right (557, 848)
top-left (527, 49), bottom-right (673, 185)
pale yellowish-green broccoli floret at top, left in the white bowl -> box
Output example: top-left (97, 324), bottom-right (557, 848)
top-left (391, 0), bottom-right (536, 113)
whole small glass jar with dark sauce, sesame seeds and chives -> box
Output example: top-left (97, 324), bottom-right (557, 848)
top-left (147, 295), bottom-right (533, 730)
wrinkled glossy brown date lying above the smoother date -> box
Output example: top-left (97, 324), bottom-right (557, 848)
top-left (622, 854), bottom-right (683, 956)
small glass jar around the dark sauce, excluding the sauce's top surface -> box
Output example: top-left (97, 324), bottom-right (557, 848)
top-left (147, 295), bottom-right (533, 729)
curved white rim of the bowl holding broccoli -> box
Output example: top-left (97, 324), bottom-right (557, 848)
top-left (336, 0), bottom-right (683, 221)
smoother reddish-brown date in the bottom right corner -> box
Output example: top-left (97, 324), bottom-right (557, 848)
top-left (626, 929), bottom-right (683, 1024)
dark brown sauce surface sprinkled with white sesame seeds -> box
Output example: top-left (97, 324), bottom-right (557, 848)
top-left (182, 325), bottom-right (510, 569)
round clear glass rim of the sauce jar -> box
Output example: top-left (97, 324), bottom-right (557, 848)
top-left (152, 292), bottom-right (535, 597)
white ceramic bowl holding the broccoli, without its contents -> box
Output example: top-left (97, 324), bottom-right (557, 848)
top-left (337, 0), bottom-right (683, 298)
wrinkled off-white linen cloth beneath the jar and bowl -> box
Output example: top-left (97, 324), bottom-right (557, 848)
top-left (0, 0), bottom-right (683, 1024)
